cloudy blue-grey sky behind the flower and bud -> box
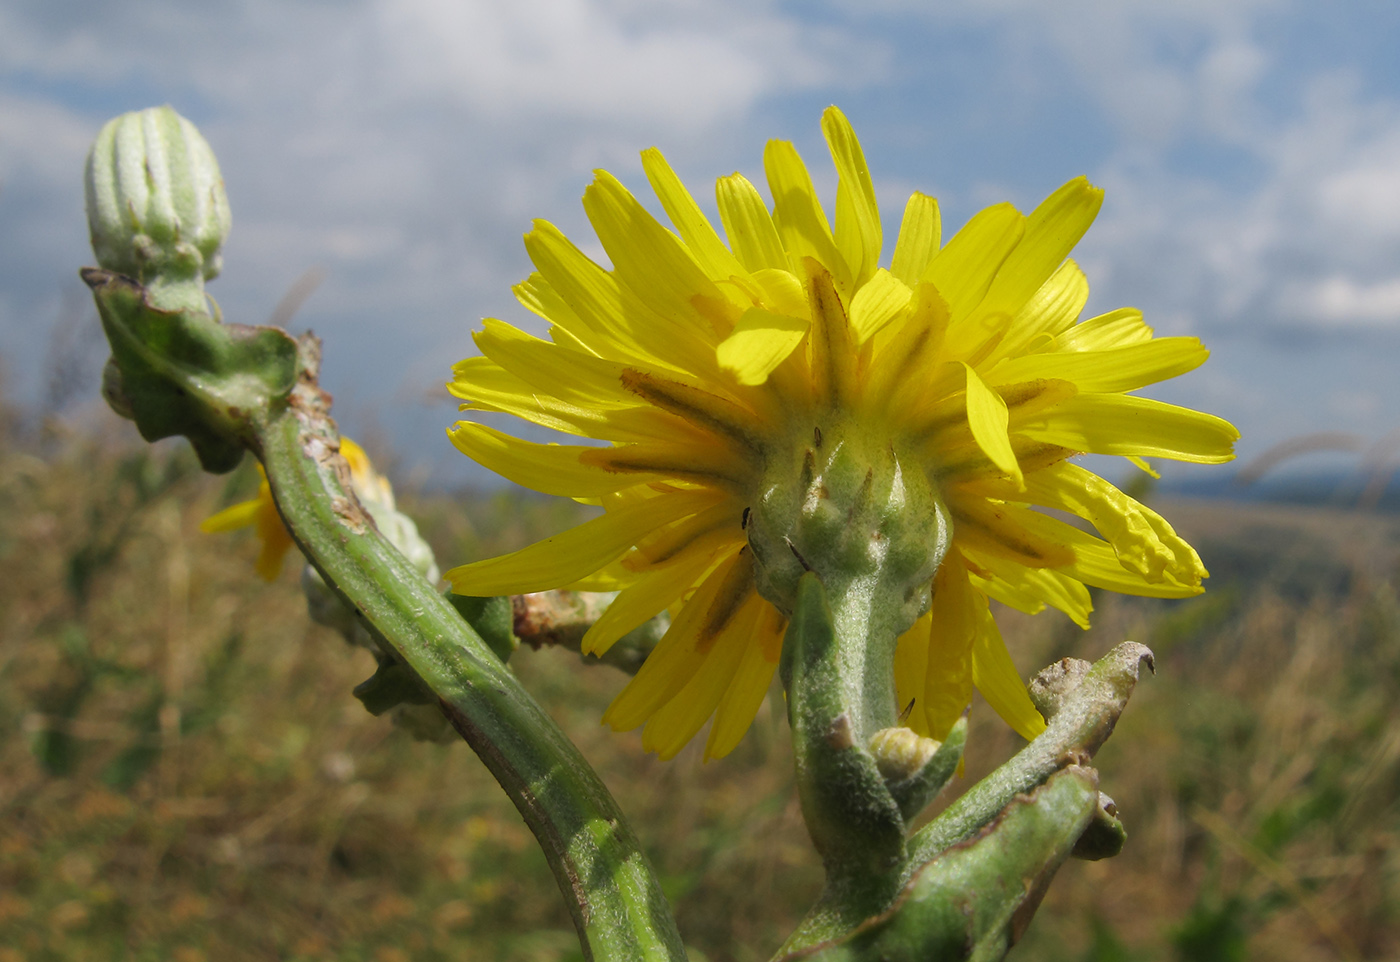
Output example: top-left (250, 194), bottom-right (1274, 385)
top-left (0, 0), bottom-right (1400, 483)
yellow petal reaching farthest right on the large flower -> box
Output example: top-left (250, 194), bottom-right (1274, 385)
top-left (1015, 393), bottom-right (1239, 465)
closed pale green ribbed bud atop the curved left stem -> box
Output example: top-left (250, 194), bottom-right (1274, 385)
top-left (85, 106), bottom-right (231, 284)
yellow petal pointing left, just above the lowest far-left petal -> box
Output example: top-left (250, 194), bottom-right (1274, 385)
top-left (447, 421), bottom-right (655, 497)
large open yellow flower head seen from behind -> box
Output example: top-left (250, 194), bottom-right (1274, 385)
top-left (447, 108), bottom-right (1238, 758)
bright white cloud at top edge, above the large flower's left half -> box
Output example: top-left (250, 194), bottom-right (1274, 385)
top-left (374, 0), bottom-right (826, 126)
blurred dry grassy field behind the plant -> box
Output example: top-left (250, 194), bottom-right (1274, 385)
top-left (0, 394), bottom-right (1400, 962)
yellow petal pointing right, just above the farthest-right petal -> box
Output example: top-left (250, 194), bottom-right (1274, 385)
top-left (987, 337), bottom-right (1210, 393)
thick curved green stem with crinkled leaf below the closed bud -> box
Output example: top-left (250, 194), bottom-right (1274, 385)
top-left (84, 269), bottom-right (685, 959)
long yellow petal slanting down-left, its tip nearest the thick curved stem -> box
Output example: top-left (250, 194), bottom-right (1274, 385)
top-left (445, 492), bottom-right (720, 598)
